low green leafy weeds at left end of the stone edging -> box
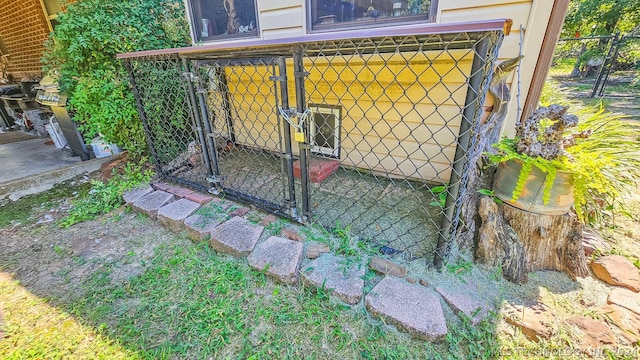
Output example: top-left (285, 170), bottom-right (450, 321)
top-left (60, 162), bottom-right (153, 228)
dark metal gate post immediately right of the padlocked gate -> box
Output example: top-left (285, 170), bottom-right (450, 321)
top-left (293, 46), bottom-right (311, 217)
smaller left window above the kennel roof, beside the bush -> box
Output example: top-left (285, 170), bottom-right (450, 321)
top-left (188, 0), bottom-right (258, 42)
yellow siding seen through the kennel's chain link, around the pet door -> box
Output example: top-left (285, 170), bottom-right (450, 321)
top-left (226, 50), bottom-right (472, 183)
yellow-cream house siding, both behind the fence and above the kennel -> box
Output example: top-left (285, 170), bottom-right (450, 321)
top-left (206, 0), bottom-right (550, 182)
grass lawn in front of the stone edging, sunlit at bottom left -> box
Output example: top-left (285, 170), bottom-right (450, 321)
top-left (0, 194), bottom-right (499, 359)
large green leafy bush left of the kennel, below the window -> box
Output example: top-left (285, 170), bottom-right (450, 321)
top-left (43, 0), bottom-right (189, 155)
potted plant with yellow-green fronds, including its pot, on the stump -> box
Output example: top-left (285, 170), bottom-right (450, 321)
top-left (488, 98), bottom-right (640, 223)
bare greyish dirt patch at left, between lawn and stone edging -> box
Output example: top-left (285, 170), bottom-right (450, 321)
top-left (0, 202), bottom-right (176, 300)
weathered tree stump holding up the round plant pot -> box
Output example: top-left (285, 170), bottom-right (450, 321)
top-left (476, 196), bottom-right (589, 283)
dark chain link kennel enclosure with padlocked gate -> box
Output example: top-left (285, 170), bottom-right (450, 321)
top-left (124, 31), bottom-right (503, 263)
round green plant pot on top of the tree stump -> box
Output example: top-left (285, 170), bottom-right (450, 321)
top-left (493, 160), bottom-right (573, 215)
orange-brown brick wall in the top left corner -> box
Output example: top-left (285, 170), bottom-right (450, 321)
top-left (0, 0), bottom-right (50, 80)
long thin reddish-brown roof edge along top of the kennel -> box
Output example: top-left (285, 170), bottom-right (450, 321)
top-left (116, 19), bottom-right (508, 59)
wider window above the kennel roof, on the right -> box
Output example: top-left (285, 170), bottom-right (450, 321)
top-left (309, 0), bottom-right (438, 31)
